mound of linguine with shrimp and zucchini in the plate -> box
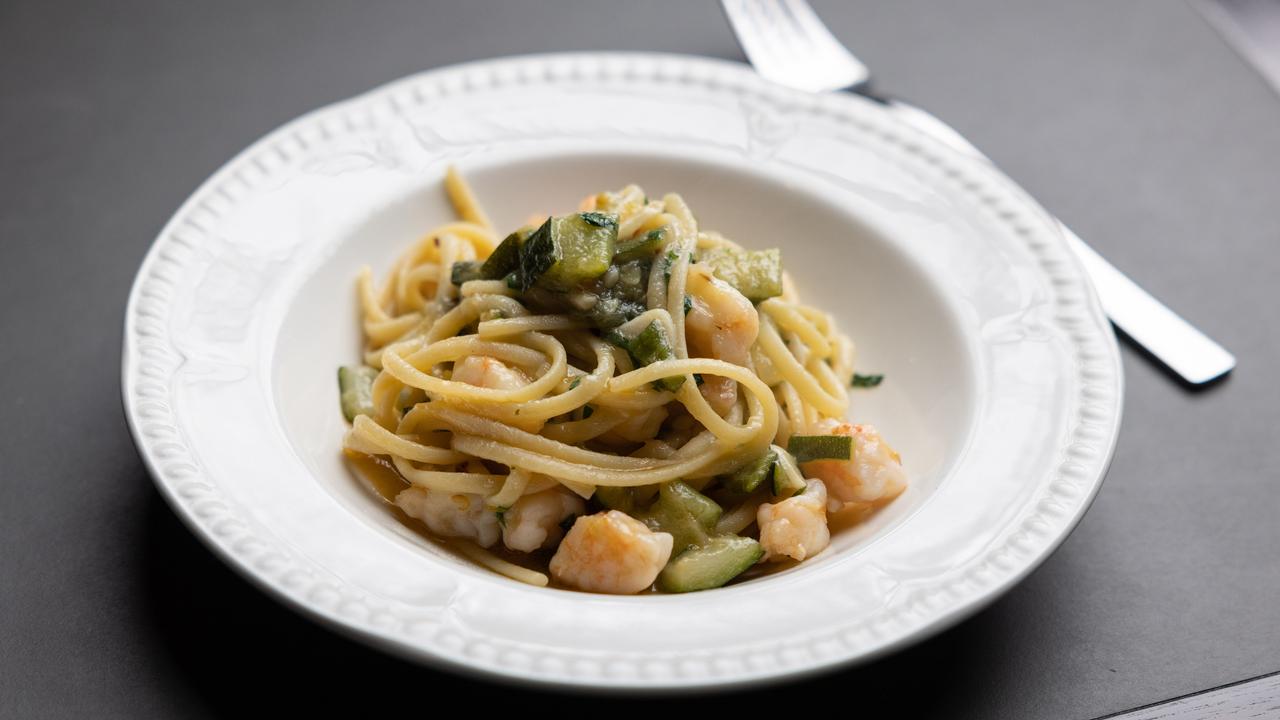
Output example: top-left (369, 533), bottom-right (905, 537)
top-left (338, 168), bottom-right (906, 593)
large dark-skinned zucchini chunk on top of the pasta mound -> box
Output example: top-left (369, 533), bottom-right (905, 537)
top-left (520, 213), bottom-right (618, 291)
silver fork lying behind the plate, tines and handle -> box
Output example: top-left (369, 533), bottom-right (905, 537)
top-left (721, 0), bottom-right (1235, 384)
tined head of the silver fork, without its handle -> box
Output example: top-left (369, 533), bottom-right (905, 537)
top-left (721, 0), bottom-right (869, 92)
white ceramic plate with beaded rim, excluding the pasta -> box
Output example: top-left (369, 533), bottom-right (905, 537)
top-left (123, 54), bottom-right (1121, 688)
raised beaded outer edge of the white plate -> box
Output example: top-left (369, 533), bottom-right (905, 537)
top-left (120, 51), bottom-right (1124, 693)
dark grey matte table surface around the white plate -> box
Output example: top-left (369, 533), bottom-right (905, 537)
top-left (0, 0), bottom-right (1280, 717)
